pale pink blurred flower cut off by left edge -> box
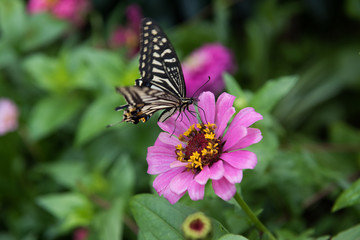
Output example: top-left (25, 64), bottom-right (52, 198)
top-left (0, 98), bottom-right (18, 136)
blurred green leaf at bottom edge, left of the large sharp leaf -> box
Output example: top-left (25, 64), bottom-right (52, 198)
top-left (94, 198), bottom-right (126, 239)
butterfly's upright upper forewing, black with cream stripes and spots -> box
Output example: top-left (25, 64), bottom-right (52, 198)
top-left (136, 18), bottom-right (186, 98)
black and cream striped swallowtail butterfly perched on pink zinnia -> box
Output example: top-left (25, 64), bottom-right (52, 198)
top-left (115, 18), bottom-right (194, 124)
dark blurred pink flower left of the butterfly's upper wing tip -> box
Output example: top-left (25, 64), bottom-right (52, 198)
top-left (110, 4), bottom-right (143, 57)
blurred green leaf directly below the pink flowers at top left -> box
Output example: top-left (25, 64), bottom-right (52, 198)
top-left (20, 13), bottom-right (67, 51)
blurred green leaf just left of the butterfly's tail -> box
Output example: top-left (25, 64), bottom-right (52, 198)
top-left (75, 91), bottom-right (122, 145)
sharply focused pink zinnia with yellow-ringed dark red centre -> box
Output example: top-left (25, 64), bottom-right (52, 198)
top-left (147, 92), bottom-right (262, 204)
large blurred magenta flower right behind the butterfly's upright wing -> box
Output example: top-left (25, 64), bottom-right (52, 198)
top-left (182, 43), bottom-right (236, 97)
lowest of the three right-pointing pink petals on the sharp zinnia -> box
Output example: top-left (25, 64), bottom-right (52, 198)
top-left (220, 150), bottom-right (257, 169)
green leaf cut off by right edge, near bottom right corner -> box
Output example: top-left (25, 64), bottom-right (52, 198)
top-left (332, 179), bottom-right (360, 212)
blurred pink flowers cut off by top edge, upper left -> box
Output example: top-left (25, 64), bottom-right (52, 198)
top-left (28, 0), bottom-right (90, 25)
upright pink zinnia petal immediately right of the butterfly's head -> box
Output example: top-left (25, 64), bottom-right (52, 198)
top-left (198, 92), bottom-right (215, 123)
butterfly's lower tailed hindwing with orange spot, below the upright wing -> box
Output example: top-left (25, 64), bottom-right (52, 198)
top-left (115, 86), bottom-right (181, 124)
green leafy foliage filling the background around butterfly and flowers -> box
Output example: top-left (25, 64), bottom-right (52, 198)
top-left (0, 0), bottom-right (360, 240)
